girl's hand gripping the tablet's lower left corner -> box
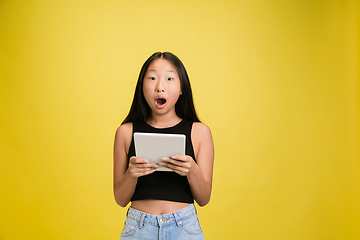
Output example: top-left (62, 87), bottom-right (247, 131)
top-left (127, 156), bottom-right (158, 178)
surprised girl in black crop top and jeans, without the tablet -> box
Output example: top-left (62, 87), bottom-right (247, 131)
top-left (114, 52), bottom-right (214, 239)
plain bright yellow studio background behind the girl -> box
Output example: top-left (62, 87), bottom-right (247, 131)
top-left (0, 0), bottom-right (360, 240)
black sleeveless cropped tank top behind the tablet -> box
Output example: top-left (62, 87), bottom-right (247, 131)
top-left (128, 120), bottom-right (196, 203)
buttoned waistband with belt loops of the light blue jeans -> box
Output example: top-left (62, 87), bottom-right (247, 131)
top-left (127, 203), bottom-right (197, 228)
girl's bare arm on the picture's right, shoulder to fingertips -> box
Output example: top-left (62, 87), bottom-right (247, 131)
top-left (164, 123), bottom-right (214, 206)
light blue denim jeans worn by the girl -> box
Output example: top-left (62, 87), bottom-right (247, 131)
top-left (120, 204), bottom-right (204, 240)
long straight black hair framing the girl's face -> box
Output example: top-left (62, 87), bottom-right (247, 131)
top-left (121, 52), bottom-right (200, 124)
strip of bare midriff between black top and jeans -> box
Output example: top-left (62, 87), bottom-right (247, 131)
top-left (131, 199), bottom-right (190, 215)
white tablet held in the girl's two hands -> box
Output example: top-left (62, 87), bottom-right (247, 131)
top-left (134, 132), bottom-right (186, 171)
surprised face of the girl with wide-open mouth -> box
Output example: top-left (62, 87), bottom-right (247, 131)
top-left (143, 58), bottom-right (181, 114)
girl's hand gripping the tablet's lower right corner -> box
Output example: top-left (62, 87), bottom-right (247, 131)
top-left (160, 155), bottom-right (197, 176)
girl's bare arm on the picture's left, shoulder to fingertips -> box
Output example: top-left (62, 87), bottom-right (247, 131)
top-left (114, 123), bottom-right (157, 207)
